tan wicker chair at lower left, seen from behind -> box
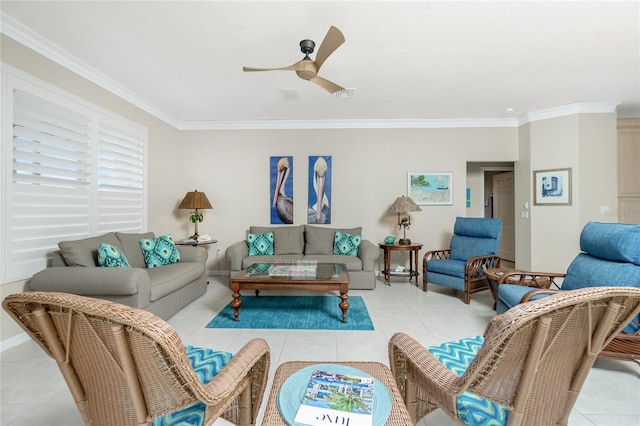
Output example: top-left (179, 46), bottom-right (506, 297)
top-left (2, 292), bottom-right (270, 426)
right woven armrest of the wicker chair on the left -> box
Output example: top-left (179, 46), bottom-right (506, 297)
top-left (200, 338), bottom-right (270, 412)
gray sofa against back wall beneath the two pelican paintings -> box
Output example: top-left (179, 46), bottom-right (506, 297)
top-left (225, 225), bottom-right (380, 290)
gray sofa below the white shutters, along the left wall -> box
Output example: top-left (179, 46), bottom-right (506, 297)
top-left (29, 232), bottom-right (207, 319)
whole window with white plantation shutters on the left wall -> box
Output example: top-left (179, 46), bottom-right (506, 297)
top-left (1, 67), bottom-right (147, 283)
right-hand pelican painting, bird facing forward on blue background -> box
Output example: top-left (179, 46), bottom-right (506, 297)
top-left (307, 156), bottom-right (331, 223)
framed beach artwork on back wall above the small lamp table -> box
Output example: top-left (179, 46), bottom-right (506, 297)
top-left (407, 172), bottom-right (453, 206)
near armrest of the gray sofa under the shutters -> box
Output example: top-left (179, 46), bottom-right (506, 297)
top-left (29, 266), bottom-right (151, 301)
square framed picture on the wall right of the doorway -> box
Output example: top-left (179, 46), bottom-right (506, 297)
top-left (533, 167), bottom-right (572, 206)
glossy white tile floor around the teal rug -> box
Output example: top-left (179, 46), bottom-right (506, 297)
top-left (0, 276), bottom-right (640, 426)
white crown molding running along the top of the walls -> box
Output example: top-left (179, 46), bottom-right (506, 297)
top-left (0, 11), bottom-right (620, 130)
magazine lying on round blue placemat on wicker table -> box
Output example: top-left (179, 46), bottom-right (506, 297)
top-left (294, 370), bottom-right (373, 426)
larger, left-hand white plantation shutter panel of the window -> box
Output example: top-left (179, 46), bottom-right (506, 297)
top-left (5, 89), bottom-right (91, 281)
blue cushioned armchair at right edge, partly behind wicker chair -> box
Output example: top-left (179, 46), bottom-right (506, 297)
top-left (496, 222), bottom-right (640, 364)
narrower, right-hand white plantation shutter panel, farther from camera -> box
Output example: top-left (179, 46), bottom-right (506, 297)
top-left (96, 119), bottom-right (146, 233)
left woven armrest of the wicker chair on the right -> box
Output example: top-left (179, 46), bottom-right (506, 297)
top-left (389, 333), bottom-right (464, 423)
